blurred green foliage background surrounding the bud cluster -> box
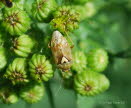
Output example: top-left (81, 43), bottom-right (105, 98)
top-left (0, 0), bottom-right (131, 108)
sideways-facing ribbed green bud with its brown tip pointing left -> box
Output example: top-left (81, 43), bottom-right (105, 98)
top-left (11, 35), bottom-right (35, 57)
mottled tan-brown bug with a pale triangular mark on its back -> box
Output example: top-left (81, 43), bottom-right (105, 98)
top-left (50, 31), bottom-right (72, 71)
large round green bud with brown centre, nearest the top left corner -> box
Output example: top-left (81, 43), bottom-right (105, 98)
top-left (2, 5), bottom-right (30, 35)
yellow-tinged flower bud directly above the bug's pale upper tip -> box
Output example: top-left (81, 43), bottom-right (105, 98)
top-left (50, 6), bottom-right (79, 33)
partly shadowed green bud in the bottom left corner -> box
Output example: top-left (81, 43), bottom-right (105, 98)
top-left (0, 88), bottom-right (18, 104)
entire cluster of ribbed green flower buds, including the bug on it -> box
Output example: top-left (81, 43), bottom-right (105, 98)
top-left (0, 0), bottom-right (110, 104)
